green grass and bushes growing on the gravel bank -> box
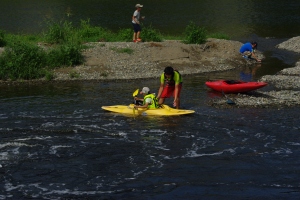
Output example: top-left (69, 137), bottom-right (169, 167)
top-left (0, 19), bottom-right (229, 80)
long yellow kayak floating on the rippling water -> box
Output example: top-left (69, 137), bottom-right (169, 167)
top-left (101, 104), bottom-right (195, 115)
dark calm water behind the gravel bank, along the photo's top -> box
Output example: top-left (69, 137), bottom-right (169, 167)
top-left (0, 0), bottom-right (300, 39)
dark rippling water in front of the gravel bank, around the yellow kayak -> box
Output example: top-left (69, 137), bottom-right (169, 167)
top-left (0, 72), bottom-right (300, 199)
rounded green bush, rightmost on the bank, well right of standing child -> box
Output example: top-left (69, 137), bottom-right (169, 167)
top-left (184, 22), bottom-right (207, 44)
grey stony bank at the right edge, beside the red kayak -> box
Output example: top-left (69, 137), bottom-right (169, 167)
top-left (209, 37), bottom-right (300, 108)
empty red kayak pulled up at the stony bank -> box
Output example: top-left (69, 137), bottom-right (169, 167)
top-left (205, 80), bottom-right (267, 93)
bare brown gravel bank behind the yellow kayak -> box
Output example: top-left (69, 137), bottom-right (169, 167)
top-left (55, 39), bottom-right (245, 80)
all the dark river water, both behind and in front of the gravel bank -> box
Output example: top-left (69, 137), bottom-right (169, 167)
top-left (0, 0), bottom-right (300, 199)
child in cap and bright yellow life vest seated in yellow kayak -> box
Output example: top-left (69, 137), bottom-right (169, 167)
top-left (134, 87), bottom-right (159, 109)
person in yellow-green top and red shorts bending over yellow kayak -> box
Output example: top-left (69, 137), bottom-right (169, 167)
top-left (157, 66), bottom-right (182, 109)
